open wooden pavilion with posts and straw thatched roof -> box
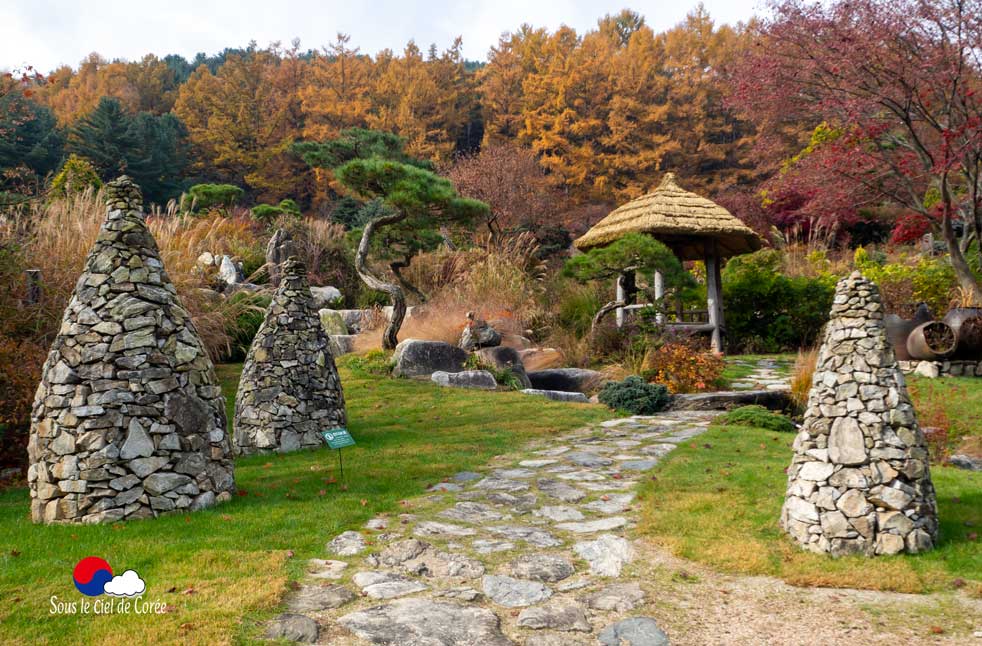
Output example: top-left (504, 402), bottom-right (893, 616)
top-left (573, 173), bottom-right (761, 351)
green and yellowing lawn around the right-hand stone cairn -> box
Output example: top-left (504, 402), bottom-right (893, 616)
top-left (639, 426), bottom-right (982, 594)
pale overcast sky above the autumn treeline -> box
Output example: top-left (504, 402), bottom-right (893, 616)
top-left (0, 0), bottom-right (761, 72)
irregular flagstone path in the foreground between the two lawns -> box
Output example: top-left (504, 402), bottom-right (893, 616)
top-left (266, 411), bottom-right (716, 646)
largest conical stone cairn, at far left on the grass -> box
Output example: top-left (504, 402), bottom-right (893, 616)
top-left (28, 176), bottom-right (235, 523)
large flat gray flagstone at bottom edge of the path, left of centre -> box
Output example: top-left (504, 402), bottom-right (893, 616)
top-left (338, 599), bottom-right (513, 646)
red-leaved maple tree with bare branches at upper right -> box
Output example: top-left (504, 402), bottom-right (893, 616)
top-left (731, 0), bottom-right (982, 300)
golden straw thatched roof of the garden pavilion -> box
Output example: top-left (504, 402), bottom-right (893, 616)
top-left (573, 173), bottom-right (760, 260)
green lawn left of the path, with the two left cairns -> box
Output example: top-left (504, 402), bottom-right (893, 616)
top-left (0, 361), bottom-right (611, 644)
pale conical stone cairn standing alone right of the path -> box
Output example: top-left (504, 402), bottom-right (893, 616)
top-left (781, 272), bottom-right (938, 556)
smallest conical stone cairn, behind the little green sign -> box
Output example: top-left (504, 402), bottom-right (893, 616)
top-left (235, 257), bottom-right (347, 453)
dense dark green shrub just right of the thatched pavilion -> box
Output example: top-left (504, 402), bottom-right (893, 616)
top-left (723, 249), bottom-right (836, 352)
